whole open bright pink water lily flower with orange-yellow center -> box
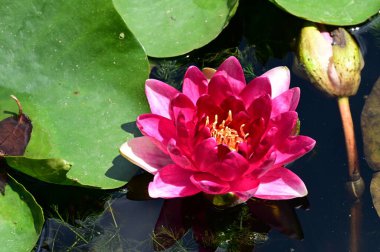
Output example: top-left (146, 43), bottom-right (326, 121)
top-left (120, 57), bottom-right (315, 200)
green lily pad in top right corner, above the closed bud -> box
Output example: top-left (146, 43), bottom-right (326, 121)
top-left (270, 0), bottom-right (380, 25)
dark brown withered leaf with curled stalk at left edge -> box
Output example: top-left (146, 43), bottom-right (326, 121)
top-left (0, 95), bottom-right (33, 157)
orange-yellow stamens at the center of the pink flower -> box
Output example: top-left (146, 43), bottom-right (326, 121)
top-left (206, 110), bottom-right (249, 151)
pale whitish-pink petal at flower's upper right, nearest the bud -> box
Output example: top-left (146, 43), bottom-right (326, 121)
top-left (261, 67), bottom-right (290, 98)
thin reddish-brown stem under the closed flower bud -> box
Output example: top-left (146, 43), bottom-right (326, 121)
top-left (338, 96), bottom-right (364, 198)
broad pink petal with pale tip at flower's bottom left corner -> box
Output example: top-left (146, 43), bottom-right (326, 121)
top-left (148, 164), bottom-right (200, 199)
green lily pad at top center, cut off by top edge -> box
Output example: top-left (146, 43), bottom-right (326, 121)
top-left (113, 0), bottom-right (238, 57)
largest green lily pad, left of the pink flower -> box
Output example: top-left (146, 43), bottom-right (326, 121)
top-left (0, 0), bottom-right (149, 189)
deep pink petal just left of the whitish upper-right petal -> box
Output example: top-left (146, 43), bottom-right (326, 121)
top-left (239, 76), bottom-right (272, 108)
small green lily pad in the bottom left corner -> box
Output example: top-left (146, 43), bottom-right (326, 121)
top-left (0, 177), bottom-right (44, 252)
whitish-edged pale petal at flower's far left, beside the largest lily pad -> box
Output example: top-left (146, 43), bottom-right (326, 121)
top-left (120, 136), bottom-right (173, 174)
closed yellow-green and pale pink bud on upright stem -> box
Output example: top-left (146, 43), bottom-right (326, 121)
top-left (298, 23), bottom-right (364, 96)
